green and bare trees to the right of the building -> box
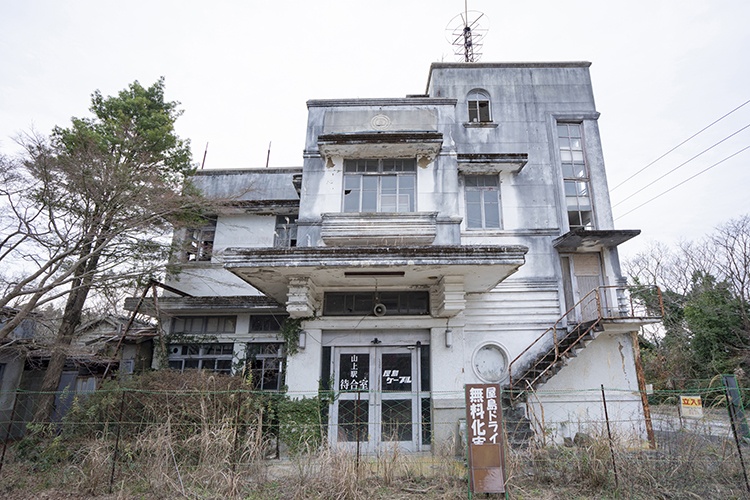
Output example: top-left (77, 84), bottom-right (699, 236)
top-left (625, 216), bottom-right (750, 389)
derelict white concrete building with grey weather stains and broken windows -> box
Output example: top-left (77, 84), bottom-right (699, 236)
top-left (131, 62), bottom-right (655, 451)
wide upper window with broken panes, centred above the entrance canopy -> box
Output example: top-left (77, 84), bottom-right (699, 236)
top-left (344, 158), bottom-right (417, 212)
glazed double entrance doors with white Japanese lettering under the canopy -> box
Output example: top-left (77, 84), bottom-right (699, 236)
top-left (329, 346), bottom-right (430, 453)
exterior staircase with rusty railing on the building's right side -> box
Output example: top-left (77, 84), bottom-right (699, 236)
top-left (502, 287), bottom-right (663, 447)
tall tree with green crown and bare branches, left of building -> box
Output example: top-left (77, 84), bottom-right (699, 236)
top-left (0, 79), bottom-right (206, 421)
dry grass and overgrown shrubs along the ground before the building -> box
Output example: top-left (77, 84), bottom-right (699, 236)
top-left (0, 370), bottom-right (750, 500)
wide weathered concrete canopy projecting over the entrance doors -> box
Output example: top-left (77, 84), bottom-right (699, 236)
top-left (224, 245), bottom-right (528, 303)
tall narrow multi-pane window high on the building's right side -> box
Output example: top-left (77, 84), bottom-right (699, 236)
top-left (557, 123), bottom-right (593, 229)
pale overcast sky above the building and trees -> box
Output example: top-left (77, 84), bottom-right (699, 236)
top-left (0, 0), bottom-right (750, 258)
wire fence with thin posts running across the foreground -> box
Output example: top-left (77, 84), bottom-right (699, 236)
top-left (0, 372), bottom-right (750, 498)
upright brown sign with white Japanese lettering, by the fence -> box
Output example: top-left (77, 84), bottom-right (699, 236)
top-left (466, 384), bottom-right (505, 493)
